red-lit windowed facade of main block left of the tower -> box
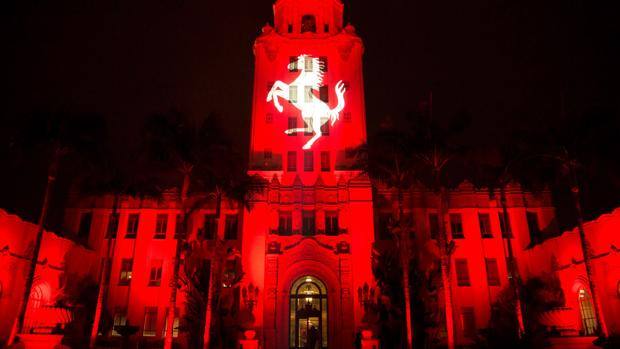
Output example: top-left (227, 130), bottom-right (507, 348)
top-left (65, 193), bottom-right (241, 343)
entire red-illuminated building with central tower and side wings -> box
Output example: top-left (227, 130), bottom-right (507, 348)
top-left (0, 0), bottom-right (620, 349)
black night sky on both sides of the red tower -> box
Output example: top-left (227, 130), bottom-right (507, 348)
top-left (0, 0), bottom-right (620, 224)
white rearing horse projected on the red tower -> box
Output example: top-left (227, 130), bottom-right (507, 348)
top-left (267, 55), bottom-right (346, 149)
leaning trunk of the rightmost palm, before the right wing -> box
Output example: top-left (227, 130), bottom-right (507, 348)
top-left (571, 185), bottom-right (609, 338)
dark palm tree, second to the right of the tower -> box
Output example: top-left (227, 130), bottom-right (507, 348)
top-left (409, 113), bottom-right (469, 349)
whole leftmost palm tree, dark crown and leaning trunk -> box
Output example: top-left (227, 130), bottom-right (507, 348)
top-left (7, 112), bottom-right (105, 345)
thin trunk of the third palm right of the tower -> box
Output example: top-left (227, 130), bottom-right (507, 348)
top-left (500, 185), bottom-right (525, 339)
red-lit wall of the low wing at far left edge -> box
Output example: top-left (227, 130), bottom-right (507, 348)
top-left (0, 210), bottom-right (96, 343)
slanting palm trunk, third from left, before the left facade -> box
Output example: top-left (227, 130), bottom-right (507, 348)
top-left (164, 171), bottom-right (191, 349)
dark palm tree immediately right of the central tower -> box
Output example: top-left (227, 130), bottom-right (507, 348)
top-left (358, 123), bottom-right (416, 348)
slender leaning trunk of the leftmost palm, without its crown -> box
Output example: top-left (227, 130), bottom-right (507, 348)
top-left (7, 151), bottom-right (60, 345)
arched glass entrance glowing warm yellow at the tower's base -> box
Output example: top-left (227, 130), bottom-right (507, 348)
top-left (289, 276), bottom-right (327, 349)
